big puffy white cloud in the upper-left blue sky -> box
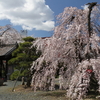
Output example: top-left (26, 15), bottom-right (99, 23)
top-left (0, 0), bottom-right (54, 31)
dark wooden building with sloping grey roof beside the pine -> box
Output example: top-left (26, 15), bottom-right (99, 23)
top-left (0, 43), bottom-right (18, 80)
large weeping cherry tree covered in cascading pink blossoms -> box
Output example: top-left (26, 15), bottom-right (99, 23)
top-left (31, 2), bottom-right (100, 100)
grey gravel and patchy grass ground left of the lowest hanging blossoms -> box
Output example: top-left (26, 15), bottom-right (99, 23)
top-left (0, 81), bottom-right (66, 100)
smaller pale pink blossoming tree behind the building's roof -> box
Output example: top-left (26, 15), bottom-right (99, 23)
top-left (0, 25), bottom-right (22, 45)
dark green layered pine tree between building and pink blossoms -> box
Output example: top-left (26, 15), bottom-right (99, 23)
top-left (9, 37), bottom-right (41, 86)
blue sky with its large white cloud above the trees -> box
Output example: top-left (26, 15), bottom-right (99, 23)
top-left (0, 0), bottom-right (100, 37)
